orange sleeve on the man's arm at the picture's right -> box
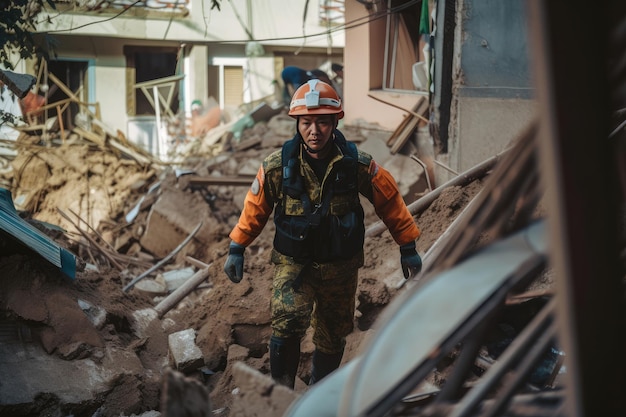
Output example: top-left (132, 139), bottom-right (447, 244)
top-left (369, 161), bottom-right (420, 245)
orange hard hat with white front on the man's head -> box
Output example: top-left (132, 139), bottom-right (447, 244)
top-left (289, 79), bottom-right (343, 119)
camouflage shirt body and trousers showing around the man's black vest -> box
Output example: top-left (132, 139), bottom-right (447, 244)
top-left (263, 139), bottom-right (372, 353)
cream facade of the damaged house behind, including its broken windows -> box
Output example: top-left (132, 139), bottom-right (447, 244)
top-left (24, 0), bottom-right (344, 156)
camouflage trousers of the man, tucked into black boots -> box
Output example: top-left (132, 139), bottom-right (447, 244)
top-left (270, 251), bottom-right (362, 354)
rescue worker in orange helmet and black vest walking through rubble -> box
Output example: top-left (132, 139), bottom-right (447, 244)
top-left (224, 79), bottom-right (422, 389)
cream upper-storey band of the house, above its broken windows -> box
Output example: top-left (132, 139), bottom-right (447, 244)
top-left (38, 0), bottom-right (345, 48)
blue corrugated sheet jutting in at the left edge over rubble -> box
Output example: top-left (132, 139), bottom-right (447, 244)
top-left (0, 188), bottom-right (76, 279)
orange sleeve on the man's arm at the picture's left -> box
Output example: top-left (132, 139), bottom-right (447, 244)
top-left (228, 167), bottom-right (273, 246)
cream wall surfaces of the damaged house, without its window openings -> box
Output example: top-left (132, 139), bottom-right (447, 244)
top-left (33, 0), bottom-right (345, 137)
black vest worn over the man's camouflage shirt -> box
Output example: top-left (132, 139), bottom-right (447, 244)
top-left (274, 131), bottom-right (365, 263)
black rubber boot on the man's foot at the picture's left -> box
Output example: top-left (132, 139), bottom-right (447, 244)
top-left (270, 336), bottom-right (300, 389)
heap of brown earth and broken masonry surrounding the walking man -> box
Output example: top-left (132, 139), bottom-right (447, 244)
top-left (0, 108), bottom-right (480, 416)
